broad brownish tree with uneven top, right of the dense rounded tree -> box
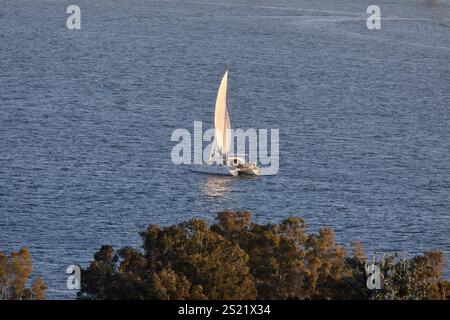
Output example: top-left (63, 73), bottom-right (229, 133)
top-left (212, 211), bottom-right (349, 299)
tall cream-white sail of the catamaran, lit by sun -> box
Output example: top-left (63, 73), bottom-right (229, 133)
top-left (214, 71), bottom-right (231, 155)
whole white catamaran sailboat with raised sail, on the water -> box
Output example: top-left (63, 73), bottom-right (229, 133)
top-left (194, 70), bottom-right (261, 176)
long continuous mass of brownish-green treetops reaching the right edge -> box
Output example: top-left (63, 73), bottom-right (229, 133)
top-left (78, 211), bottom-right (450, 300)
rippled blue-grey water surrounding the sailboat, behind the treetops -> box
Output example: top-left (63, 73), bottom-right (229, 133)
top-left (0, 0), bottom-right (450, 298)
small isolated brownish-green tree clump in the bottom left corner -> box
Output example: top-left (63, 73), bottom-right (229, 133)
top-left (0, 247), bottom-right (47, 300)
